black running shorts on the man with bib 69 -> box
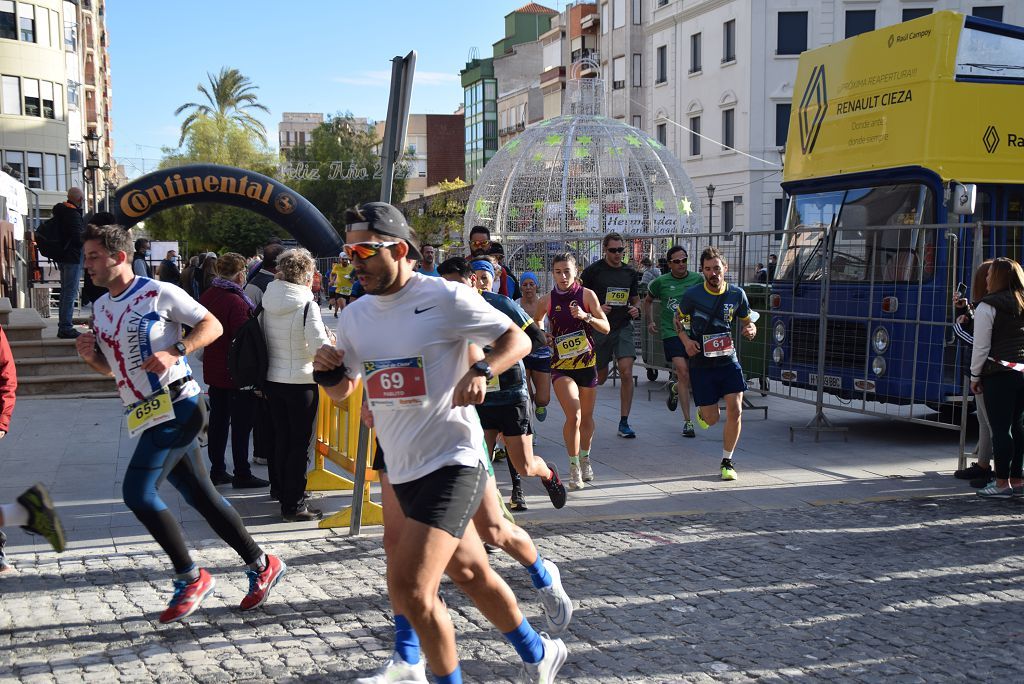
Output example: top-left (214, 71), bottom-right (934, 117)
top-left (391, 463), bottom-right (487, 539)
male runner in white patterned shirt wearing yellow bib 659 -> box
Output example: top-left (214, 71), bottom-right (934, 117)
top-left (76, 225), bottom-right (286, 623)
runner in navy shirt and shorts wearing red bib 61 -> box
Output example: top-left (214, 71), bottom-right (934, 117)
top-left (676, 247), bottom-right (758, 480)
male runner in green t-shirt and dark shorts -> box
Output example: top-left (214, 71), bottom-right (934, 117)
top-left (643, 245), bottom-right (703, 437)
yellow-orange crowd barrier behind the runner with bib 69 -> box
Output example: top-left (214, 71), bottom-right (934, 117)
top-left (306, 385), bottom-right (384, 528)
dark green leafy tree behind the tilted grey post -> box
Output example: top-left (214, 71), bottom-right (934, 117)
top-left (284, 113), bottom-right (408, 231)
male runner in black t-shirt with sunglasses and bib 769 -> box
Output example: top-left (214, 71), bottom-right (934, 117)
top-left (580, 232), bottom-right (640, 439)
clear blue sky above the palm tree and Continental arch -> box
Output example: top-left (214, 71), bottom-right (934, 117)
top-left (106, 0), bottom-right (532, 177)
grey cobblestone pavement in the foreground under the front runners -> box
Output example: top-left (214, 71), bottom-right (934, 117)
top-left (0, 496), bottom-right (1024, 684)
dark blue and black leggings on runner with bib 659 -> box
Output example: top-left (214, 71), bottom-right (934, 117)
top-left (122, 396), bottom-right (263, 573)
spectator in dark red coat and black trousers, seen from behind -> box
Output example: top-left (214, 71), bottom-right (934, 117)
top-left (199, 252), bottom-right (269, 489)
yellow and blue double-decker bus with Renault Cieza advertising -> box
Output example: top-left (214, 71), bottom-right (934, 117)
top-left (769, 11), bottom-right (1024, 408)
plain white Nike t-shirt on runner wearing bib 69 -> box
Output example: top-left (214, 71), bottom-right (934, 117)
top-left (337, 273), bottom-right (514, 484)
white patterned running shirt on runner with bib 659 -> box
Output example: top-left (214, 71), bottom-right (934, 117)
top-left (92, 276), bottom-right (208, 405)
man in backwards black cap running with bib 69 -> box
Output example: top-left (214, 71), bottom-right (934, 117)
top-left (313, 202), bottom-right (567, 684)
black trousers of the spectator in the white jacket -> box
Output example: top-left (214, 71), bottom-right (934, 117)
top-left (266, 382), bottom-right (319, 513)
